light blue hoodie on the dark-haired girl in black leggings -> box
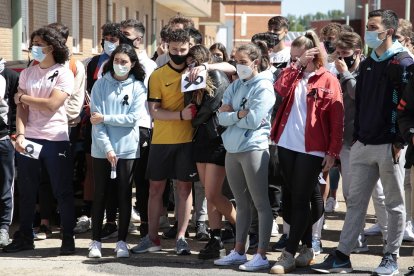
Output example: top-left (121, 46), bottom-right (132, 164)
top-left (91, 72), bottom-right (147, 159)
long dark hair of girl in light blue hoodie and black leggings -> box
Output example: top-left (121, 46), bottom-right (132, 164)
top-left (103, 44), bottom-right (145, 81)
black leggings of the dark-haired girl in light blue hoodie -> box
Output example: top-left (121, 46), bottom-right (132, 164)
top-left (92, 158), bottom-right (135, 241)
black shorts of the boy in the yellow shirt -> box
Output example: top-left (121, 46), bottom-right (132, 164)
top-left (146, 142), bottom-right (199, 182)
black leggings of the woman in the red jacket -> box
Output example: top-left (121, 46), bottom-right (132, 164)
top-left (278, 147), bottom-right (323, 255)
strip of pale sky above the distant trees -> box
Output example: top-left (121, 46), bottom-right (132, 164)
top-left (282, 0), bottom-right (344, 16)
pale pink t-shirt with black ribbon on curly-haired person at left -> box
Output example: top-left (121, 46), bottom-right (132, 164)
top-left (19, 64), bottom-right (74, 141)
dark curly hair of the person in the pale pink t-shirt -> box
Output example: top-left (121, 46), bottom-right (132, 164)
top-left (30, 27), bottom-right (69, 64)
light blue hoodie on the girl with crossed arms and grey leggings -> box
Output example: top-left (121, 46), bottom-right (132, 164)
top-left (218, 71), bottom-right (275, 153)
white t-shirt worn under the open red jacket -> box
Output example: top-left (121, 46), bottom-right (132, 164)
top-left (277, 72), bottom-right (325, 157)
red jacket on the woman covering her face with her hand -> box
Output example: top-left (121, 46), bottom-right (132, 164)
top-left (270, 67), bottom-right (344, 158)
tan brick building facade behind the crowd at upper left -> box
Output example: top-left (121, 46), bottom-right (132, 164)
top-left (0, 0), bottom-right (215, 61)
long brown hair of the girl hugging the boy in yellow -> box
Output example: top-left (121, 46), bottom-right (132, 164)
top-left (187, 45), bottom-right (216, 105)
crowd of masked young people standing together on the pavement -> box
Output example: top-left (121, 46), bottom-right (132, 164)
top-left (0, 7), bottom-right (414, 275)
